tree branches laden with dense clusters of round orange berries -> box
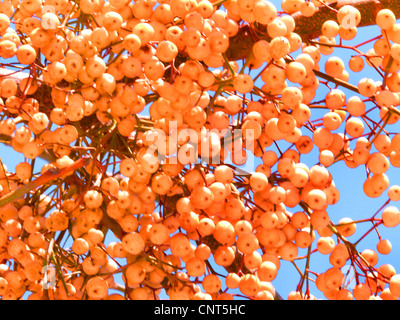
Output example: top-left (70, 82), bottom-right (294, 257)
top-left (0, 0), bottom-right (400, 300)
